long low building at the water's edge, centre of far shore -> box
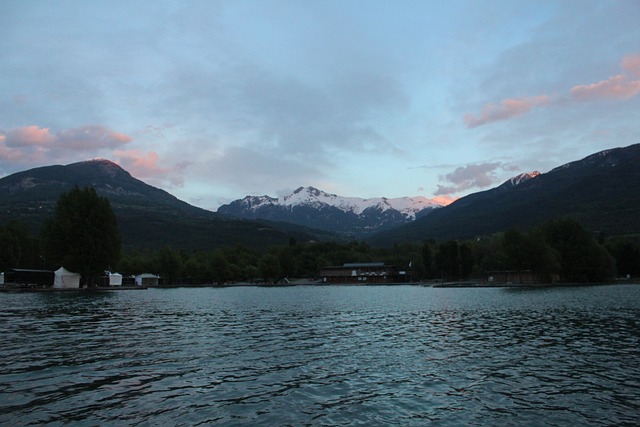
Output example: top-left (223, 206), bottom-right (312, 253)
top-left (320, 262), bottom-right (409, 285)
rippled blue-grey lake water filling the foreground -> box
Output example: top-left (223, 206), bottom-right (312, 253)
top-left (0, 286), bottom-right (640, 426)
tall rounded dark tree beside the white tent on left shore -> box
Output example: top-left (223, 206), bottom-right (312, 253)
top-left (42, 186), bottom-right (121, 286)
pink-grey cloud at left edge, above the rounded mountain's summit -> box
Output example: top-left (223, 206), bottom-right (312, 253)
top-left (0, 125), bottom-right (131, 168)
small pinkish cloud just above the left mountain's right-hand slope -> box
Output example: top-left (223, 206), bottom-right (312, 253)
top-left (113, 150), bottom-right (190, 187)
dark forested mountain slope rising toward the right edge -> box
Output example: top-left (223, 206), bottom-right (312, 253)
top-left (371, 144), bottom-right (640, 245)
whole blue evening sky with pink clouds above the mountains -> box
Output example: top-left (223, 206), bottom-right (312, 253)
top-left (0, 0), bottom-right (640, 210)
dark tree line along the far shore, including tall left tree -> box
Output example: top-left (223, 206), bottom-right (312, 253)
top-left (0, 187), bottom-right (640, 285)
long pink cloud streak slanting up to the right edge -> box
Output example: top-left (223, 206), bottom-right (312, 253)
top-left (463, 54), bottom-right (640, 128)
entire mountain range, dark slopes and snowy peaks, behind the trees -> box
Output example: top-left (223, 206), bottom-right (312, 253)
top-left (0, 144), bottom-right (640, 250)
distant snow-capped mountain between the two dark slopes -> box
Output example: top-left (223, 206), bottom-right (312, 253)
top-left (218, 187), bottom-right (448, 235)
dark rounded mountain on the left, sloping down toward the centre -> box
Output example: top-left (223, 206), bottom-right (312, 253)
top-left (0, 160), bottom-right (330, 254)
